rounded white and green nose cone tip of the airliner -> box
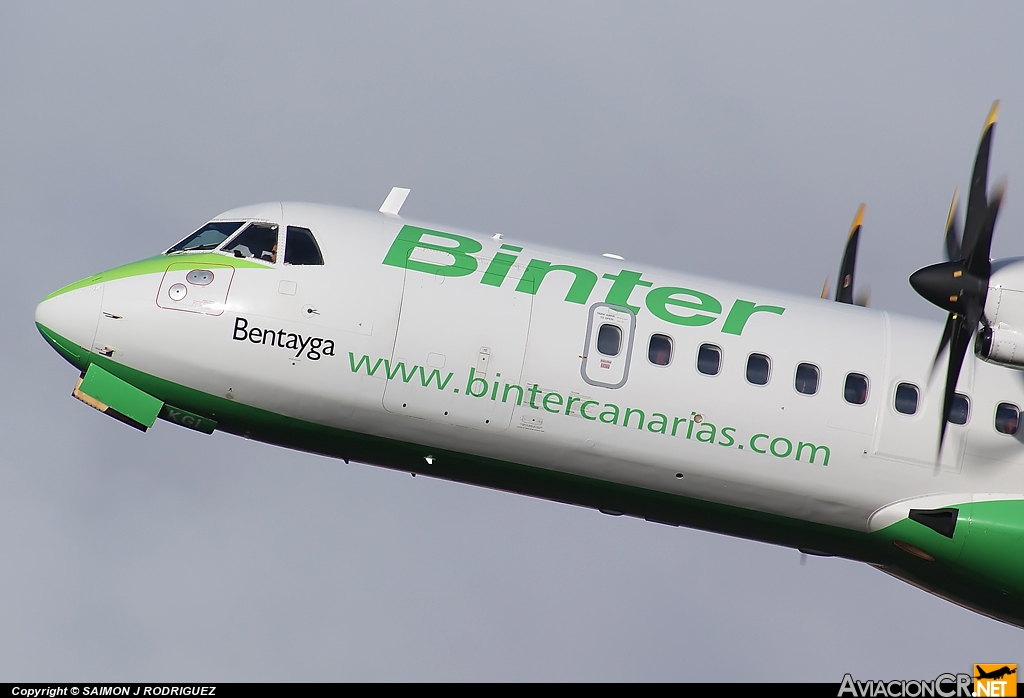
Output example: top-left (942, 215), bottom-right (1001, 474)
top-left (36, 283), bottom-right (103, 370)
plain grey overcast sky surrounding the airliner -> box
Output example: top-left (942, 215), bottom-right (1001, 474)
top-left (0, 0), bottom-right (1024, 682)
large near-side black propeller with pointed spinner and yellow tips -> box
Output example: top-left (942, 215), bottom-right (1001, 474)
top-left (910, 100), bottom-right (1006, 452)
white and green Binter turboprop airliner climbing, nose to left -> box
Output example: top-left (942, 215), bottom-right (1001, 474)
top-left (36, 105), bottom-right (1024, 626)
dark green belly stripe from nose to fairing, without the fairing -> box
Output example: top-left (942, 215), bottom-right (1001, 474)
top-left (34, 326), bottom-right (880, 564)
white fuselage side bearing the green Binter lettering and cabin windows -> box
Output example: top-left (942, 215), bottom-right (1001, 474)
top-left (66, 204), bottom-right (1024, 531)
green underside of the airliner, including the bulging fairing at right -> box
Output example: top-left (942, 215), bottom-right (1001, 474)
top-left (39, 325), bottom-right (1024, 627)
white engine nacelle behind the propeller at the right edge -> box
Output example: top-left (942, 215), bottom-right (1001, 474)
top-left (974, 257), bottom-right (1024, 368)
